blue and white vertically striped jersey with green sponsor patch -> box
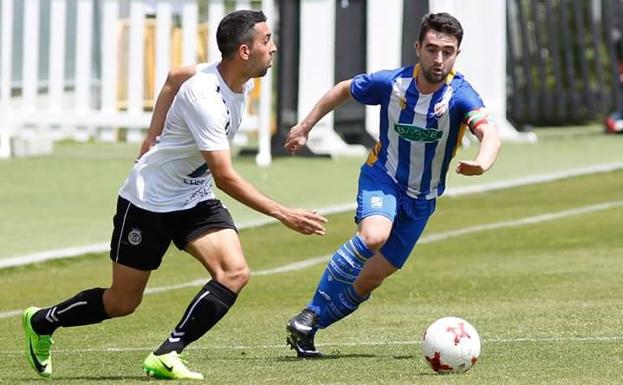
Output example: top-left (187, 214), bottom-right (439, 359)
top-left (351, 65), bottom-right (486, 199)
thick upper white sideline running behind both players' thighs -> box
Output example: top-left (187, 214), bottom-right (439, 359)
top-left (0, 162), bottom-right (623, 269)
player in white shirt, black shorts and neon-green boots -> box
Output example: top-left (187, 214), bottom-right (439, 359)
top-left (23, 11), bottom-right (326, 379)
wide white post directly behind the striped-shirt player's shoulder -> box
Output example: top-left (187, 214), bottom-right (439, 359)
top-left (366, 0), bottom-right (404, 139)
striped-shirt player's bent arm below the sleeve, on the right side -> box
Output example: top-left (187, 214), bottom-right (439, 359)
top-left (456, 109), bottom-right (502, 176)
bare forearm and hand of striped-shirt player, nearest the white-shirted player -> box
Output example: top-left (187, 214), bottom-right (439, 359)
top-left (283, 79), bottom-right (352, 155)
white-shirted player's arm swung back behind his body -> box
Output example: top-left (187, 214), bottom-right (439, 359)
top-left (138, 65), bottom-right (196, 158)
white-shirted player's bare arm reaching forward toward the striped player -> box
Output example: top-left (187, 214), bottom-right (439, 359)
top-left (201, 150), bottom-right (327, 235)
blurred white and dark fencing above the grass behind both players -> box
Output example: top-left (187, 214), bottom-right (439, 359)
top-left (0, 0), bottom-right (623, 159)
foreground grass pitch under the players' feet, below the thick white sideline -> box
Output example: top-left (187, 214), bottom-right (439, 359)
top-left (0, 164), bottom-right (623, 385)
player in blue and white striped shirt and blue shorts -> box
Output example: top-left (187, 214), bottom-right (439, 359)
top-left (285, 13), bottom-right (500, 357)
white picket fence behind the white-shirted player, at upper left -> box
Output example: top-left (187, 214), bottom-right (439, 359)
top-left (0, 0), bottom-right (275, 164)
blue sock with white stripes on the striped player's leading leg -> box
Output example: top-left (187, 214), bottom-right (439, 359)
top-left (307, 235), bottom-right (374, 328)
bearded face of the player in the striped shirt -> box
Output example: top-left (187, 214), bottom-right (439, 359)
top-left (415, 30), bottom-right (460, 84)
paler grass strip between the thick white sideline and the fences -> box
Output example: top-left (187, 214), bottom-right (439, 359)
top-left (0, 126), bottom-right (623, 258)
